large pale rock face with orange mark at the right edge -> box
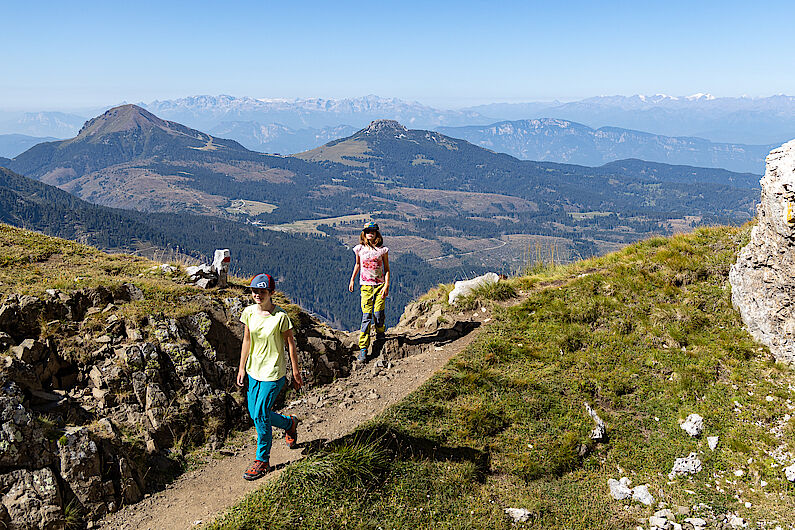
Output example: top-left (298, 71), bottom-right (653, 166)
top-left (729, 141), bottom-right (795, 363)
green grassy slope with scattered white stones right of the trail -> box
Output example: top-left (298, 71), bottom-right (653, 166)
top-left (214, 226), bottom-right (795, 528)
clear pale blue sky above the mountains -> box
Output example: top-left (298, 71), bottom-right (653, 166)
top-left (0, 0), bottom-right (795, 110)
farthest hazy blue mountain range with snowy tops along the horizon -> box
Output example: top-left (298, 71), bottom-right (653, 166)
top-left (6, 94), bottom-right (795, 146)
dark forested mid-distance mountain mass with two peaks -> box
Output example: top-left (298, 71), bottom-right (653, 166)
top-left (8, 105), bottom-right (759, 222)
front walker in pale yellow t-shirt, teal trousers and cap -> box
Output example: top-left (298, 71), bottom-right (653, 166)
top-left (237, 274), bottom-right (303, 480)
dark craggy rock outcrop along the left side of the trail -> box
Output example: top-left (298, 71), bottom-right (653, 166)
top-left (0, 284), bottom-right (353, 528)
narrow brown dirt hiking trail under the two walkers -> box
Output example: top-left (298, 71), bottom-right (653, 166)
top-left (99, 302), bottom-right (504, 530)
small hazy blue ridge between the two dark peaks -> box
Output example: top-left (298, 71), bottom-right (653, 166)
top-left (209, 121), bottom-right (356, 154)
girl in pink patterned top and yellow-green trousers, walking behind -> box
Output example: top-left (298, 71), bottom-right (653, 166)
top-left (348, 222), bottom-right (389, 362)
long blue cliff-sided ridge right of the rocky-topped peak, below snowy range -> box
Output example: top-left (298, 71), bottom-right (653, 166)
top-left (437, 118), bottom-right (774, 175)
